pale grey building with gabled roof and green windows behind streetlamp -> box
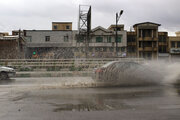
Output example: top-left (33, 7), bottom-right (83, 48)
top-left (75, 25), bottom-right (127, 58)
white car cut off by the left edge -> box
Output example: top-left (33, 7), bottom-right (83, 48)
top-left (0, 66), bottom-right (16, 80)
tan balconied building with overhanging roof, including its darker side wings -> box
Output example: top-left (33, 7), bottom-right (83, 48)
top-left (127, 22), bottom-right (168, 60)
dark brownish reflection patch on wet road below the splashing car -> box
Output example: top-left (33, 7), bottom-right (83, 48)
top-left (50, 88), bottom-right (162, 112)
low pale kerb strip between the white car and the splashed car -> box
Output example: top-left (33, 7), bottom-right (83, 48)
top-left (16, 71), bottom-right (93, 77)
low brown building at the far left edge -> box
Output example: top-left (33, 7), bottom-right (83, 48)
top-left (0, 36), bottom-right (25, 59)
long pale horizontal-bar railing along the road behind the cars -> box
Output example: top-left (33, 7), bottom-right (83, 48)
top-left (0, 58), bottom-right (144, 71)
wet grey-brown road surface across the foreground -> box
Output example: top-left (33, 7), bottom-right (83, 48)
top-left (0, 77), bottom-right (180, 120)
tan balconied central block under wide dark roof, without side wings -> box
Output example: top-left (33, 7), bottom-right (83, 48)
top-left (133, 22), bottom-right (160, 59)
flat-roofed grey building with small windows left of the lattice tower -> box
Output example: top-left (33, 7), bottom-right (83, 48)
top-left (24, 30), bottom-right (74, 59)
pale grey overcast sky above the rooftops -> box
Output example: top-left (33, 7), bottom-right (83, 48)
top-left (0, 0), bottom-right (180, 35)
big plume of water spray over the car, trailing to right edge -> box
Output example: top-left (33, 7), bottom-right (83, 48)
top-left (93, 61), bottom-right (180, 86)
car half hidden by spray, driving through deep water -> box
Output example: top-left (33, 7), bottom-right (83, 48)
top-left (94, 61), bottom-right (161, 86)
